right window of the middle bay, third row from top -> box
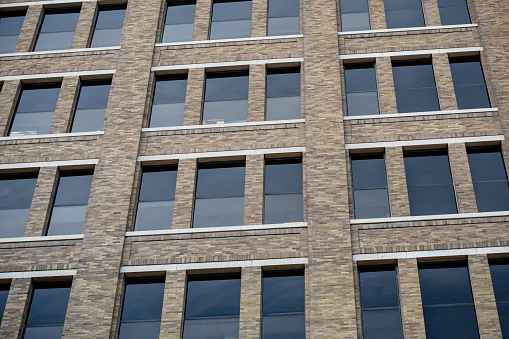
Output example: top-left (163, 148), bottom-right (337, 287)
top-left (263, 158), bottom-right (304, 224)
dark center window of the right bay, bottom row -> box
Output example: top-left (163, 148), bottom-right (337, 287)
top-left (419, 263), bottom-right (479, 339)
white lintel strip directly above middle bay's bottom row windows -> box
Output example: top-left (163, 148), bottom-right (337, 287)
top-left (120, 258), bottom-right (308, 273)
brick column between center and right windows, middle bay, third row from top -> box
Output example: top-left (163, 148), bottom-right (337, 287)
top-left (244, 154), bottom-right (265, 225)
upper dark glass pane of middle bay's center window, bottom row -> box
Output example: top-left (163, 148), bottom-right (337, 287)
top-left (185, 277), bottom-right (240, 321)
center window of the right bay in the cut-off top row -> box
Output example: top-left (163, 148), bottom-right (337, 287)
top-left (384, 0), bottom-right (425, 28)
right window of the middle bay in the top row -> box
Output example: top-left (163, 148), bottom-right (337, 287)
top-left (267, 0), bottom-right (300, 36)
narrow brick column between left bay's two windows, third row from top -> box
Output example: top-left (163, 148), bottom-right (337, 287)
top-left (24, 167), bottom-right (58, 237)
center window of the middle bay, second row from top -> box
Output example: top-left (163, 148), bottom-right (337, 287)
top-left (202, 72), bottom-right (249, 124)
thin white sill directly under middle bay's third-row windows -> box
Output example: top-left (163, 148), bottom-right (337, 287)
top-left (125, 222), bottom-right (308, 237)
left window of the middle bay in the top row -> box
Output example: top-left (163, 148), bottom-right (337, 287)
top-left (161, 1), bottom-right (196, 42)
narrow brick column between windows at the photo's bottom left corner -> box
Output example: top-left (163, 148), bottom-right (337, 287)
top-left (0, 278), bottom-right (30, 338)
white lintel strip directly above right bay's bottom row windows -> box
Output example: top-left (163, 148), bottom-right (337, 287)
top-left (353, 246), bottom-right (509, 261)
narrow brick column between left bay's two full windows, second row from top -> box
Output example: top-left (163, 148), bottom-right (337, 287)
top-left (50, 76), bottom-right (80, 133)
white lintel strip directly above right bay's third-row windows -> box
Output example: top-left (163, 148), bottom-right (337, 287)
top-left (345, 135), bottom-right (504, 149)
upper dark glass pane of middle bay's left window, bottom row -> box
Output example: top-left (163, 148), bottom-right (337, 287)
top-left (121, 281), bottom-right (164, 322)
